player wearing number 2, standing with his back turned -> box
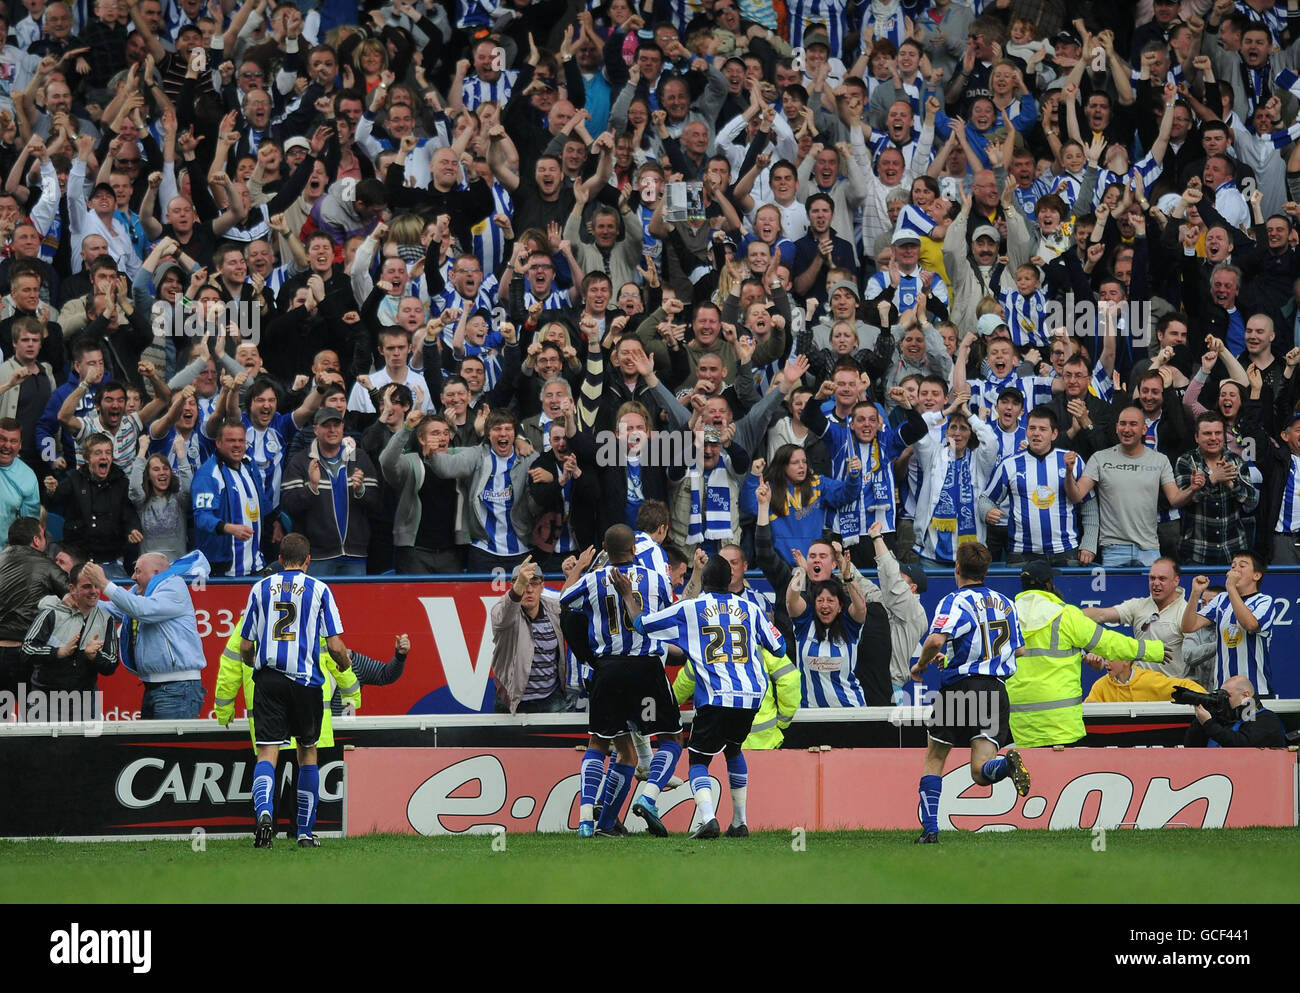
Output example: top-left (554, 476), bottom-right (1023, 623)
top-left (239, 534), bottom-right (352, 849)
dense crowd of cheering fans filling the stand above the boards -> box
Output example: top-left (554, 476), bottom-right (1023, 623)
top-left (0, 0), bottom-right (1300, 590)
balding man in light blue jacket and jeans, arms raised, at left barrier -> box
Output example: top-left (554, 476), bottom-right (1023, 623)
top-left (82, 552), bottom-right (208, 720)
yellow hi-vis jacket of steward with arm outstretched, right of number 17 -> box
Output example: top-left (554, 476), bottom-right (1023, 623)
top-left (1006, 590), bottom-right (1165, 749)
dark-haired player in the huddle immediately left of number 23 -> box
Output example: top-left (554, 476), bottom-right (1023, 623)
top-left (560, 524), bottom-right (681, 838)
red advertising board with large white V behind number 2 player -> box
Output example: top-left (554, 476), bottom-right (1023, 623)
top-left (99, 581), bottom-right (504, 720)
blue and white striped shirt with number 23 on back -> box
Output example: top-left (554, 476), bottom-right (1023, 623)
top-left (638, 593), bottom-right (785, 710)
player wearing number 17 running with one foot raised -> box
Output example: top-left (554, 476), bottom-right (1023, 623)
top-left (911, 542), bottom-right (1030, 845)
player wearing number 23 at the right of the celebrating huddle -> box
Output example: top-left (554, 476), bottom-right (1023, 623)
top-left (614, 555), bottom-right (785, 838)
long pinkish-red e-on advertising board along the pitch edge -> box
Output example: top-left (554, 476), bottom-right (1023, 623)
top-left (345, 747), bottom-right (1296, 836)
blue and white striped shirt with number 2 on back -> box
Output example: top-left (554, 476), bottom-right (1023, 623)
top-left (239, 569), bottom-right (343, 686)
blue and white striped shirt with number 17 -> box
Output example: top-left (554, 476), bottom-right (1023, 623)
top-left (928, 586), bottom-right (1024, 686)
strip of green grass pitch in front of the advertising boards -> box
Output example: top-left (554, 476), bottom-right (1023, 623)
top-left (0, 828), bottom-right (1300, 903)
